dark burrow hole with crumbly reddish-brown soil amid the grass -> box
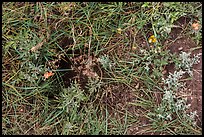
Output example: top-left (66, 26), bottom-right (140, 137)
top-left (51, 37), bottom-right (101, 89)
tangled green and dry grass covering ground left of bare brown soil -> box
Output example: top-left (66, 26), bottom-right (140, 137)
top-left (2, 2), bottom-right (202, 135)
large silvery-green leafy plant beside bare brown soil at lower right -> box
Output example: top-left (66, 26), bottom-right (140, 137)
top-left (148, 67), bottom-right (197, 126)
